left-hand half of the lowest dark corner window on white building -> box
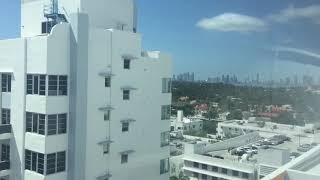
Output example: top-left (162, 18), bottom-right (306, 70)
top-left (25, 150), bottom-right (44, 174)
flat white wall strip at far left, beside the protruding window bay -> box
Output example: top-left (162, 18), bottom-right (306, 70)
top-left (0, 39), bottom-right (27, 179)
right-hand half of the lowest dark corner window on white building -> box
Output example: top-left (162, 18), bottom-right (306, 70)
top-left (47, 151), bottom-right (66, 174)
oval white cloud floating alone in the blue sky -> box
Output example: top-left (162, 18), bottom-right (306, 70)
top-left (197, 13), bottom-right (267, 32)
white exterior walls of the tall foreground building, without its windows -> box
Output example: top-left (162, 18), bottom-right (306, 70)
top-left (5, 0), bottom-right (172, 180)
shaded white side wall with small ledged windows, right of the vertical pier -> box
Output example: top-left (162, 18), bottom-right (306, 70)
top-left (86, 29), bottom-right (171, 180)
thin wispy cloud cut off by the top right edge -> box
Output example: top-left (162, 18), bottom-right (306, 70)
top-left (269, 5), bottom-right (320, 24)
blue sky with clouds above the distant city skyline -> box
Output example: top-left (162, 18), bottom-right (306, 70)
top-left (0, 0), bottom-right (320, 81)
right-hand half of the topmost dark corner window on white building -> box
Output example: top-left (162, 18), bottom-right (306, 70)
top-left (48, 75), bottom-right (68, 96)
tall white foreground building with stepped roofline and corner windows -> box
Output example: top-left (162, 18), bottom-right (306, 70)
top-left (0, 0), bottom-right (171, 180)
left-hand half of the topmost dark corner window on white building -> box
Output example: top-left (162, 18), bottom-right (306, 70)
top-left (27, 74), bottom-right (46, 96)
